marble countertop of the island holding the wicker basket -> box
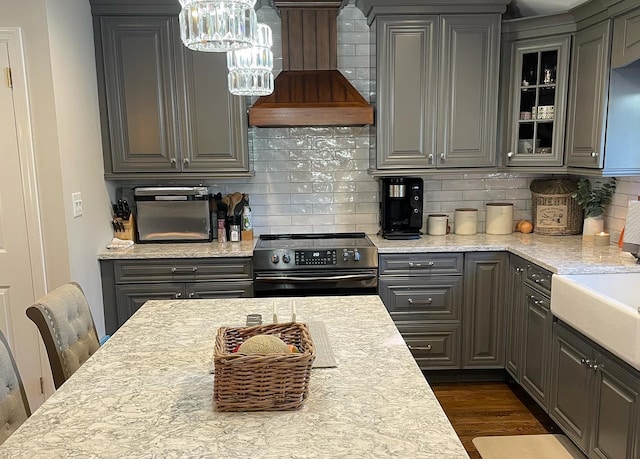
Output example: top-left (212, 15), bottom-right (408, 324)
top-left (0, 296), bottom-right (468, 459)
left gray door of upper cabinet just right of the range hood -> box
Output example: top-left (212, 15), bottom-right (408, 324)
top-left (376, 16), bottom-right (440, 169)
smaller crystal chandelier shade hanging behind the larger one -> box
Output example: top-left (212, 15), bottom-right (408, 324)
top-left (227, 23), bottom-right (273, 96)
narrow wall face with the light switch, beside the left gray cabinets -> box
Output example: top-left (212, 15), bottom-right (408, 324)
top-left (47, 0), bottom-right (113, 336)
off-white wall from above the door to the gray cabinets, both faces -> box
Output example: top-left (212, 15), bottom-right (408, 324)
top-left (0, 0), bottom-right (112, 335)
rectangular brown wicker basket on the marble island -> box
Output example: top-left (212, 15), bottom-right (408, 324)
top-left (213, 323), bottom-right (315, 411)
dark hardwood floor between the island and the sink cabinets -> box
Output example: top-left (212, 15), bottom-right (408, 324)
top-left (430, 382), bottom-right (561, 459)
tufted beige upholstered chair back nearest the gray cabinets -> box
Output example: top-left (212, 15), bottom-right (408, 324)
top-left (27, 282), bottom-right (100, 389)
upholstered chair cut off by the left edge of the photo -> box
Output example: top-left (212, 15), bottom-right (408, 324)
top-left (0, 332), bottom-right (31, 444)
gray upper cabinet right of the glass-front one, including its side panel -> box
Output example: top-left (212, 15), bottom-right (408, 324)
top-left (566, 15), bottom-right (640, 176)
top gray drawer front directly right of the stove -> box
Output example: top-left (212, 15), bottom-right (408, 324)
top-left (379, 253), bottom-right (463, 275)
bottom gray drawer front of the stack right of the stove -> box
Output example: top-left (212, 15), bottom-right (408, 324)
top-left (398, 323), bottom-right (460, 370)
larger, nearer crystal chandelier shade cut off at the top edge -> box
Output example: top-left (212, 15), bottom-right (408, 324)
top-left (179, 0), bottom-right (258, 52)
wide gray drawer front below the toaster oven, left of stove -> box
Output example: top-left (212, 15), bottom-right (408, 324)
top-left (115, 258), bottom-right (253, 284)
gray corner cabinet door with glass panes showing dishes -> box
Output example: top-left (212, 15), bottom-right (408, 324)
top-left (505, 36), bottom-right (571, 166)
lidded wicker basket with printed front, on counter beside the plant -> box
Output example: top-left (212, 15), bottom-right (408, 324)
top-left (529, 178), bottom-right (582, 236)
